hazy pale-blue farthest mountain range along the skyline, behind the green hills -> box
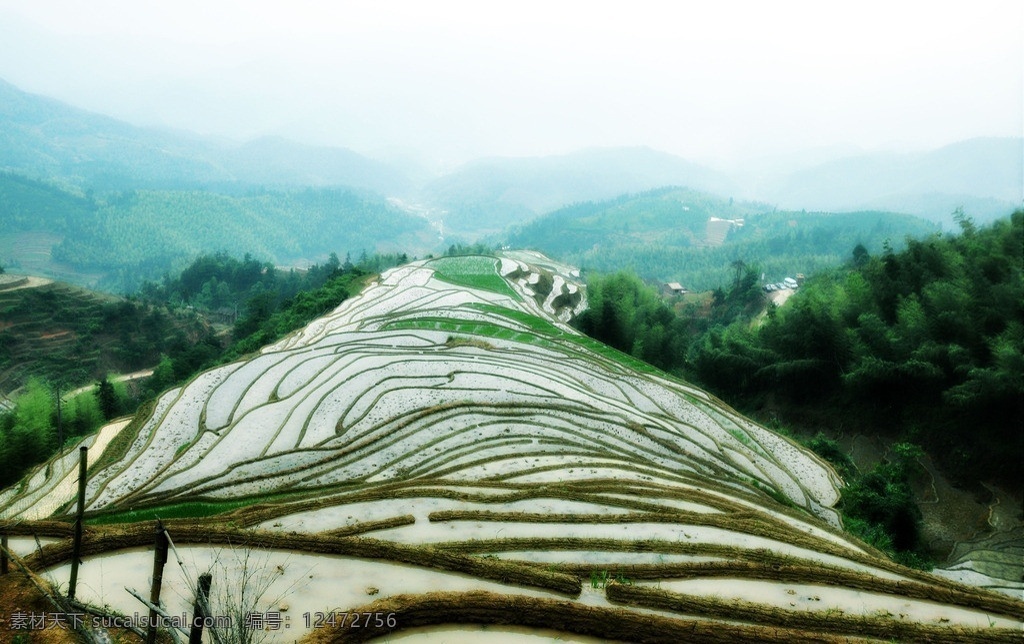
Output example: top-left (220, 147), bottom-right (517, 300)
top-left (6, 75), bottom-right (1024, 231)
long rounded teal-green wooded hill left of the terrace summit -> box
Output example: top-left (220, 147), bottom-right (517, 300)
top-left (54, 189), bottom-right (426, 271)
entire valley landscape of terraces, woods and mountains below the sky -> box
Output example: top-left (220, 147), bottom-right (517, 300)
top-left (0, 70), bottom-right (1024, 644)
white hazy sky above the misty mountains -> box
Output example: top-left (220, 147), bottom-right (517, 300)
top-left (0, 0), bottom-right (1024, 163)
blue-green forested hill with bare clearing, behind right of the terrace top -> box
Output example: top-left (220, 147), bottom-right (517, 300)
top-left (508, 187), bottom-right (937, 290)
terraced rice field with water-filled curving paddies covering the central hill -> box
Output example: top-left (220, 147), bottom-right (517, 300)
top-left (0, 252), bottom-right (1024, 641)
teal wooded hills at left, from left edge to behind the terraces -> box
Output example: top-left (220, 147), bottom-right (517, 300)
top-left (0, 174), bottom-right (436, 292)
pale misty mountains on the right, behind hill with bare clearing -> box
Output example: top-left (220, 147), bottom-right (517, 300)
top-left (419, 138), bottom-right (1024, 233)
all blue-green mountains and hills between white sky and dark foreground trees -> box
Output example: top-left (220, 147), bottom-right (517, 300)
top-left (0, 74), bottom-right (1024, 286)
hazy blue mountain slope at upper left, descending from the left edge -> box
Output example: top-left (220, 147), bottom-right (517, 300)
top-left (0, 80), bottom-right (410, 195)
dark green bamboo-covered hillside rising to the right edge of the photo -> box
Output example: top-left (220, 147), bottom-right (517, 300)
top-left (689, 211), bottom-right (1024, 487)
